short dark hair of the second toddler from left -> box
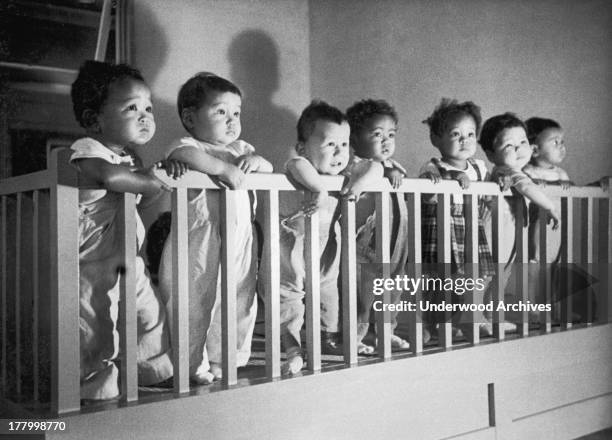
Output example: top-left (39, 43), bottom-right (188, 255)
top-left (176, 72), bottom-right (242, 129)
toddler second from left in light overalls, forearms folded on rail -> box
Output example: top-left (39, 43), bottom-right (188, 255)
top-left (159, 73), bottom-right (272, 385)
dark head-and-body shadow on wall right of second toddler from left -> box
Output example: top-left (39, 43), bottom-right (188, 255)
top-left (228, 29), bottom-right (297, 172)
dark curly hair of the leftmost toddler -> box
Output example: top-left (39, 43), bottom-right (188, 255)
top-left (70, 60), bottom-right (145, 128)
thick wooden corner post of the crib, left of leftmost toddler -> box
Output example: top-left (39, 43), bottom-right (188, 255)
top-left (50, 151), bottom-right (80, 414)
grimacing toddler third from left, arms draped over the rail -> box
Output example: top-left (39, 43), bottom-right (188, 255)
top-left (280, 101), bottom-right (382, 374)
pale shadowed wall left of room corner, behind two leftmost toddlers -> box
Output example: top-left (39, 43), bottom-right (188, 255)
top-left (132, 0), bottom-right (310, 168)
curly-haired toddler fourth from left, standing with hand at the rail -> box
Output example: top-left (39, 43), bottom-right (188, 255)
top-left (346, 99), bottom-right (410, 354)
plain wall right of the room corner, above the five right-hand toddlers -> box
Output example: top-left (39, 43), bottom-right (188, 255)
top-left (310, 0), bottom-right (612, 183)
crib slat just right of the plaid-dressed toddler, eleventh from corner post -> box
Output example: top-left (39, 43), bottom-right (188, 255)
top-left (491, 195), bottom-right (508, 341)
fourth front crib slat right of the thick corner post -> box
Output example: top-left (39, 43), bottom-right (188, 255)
top-left (262, 190), bottom-right (281, 379)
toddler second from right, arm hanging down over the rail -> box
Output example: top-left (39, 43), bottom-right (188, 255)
top-left (480, 113), bottom-right (559, 320)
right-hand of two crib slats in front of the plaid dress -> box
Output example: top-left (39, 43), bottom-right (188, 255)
top-left (463, 194), bottom-right (480, 344)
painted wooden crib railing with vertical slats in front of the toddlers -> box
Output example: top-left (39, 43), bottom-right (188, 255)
top-left (0, 151), bottom-right (612, 414)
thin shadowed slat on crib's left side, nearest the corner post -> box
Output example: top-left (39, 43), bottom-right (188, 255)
top-left (32, 191), bottom-right (40, 401)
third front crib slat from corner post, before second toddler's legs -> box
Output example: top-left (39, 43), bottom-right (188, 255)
top-left (221, 189), bottom-right (238, 385)
